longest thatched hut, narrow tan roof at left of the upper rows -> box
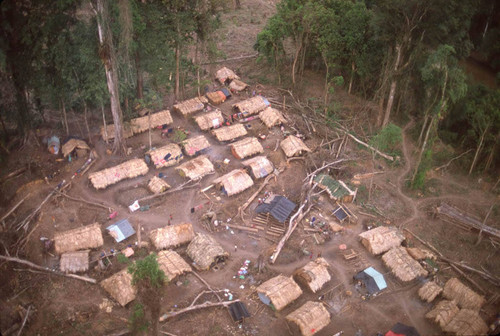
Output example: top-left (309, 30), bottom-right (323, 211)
top-left (89, 159), bottom-right (149, 189)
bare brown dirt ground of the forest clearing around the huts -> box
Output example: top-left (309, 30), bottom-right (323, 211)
top-left (0, 0), bottom-right (500, 336)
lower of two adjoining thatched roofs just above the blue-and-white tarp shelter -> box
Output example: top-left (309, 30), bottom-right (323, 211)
top-left (382, 246), bottom-right (429, 281)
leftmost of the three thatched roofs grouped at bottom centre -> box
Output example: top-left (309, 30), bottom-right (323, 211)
top-left (257, 275), bottom-right (302, 310)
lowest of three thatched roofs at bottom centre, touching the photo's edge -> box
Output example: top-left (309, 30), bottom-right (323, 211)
top-left (286, 301), bottom-right (330, 336)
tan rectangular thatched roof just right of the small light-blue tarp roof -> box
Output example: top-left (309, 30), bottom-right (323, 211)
top-left (149, 223), bottom-right (194, 250)
